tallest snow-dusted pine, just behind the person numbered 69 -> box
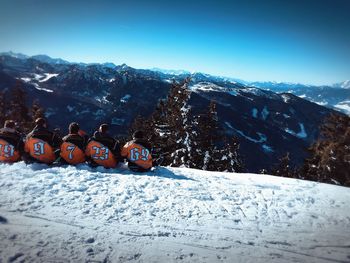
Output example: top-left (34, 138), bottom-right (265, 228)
top-left (130, 80), bottom-right (193, 167)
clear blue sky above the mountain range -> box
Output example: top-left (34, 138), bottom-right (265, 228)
top-left (0, 0), bottom-right (350, 84)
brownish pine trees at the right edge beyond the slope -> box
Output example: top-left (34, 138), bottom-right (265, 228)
top-left (302, 114), bottom-right (350, 186)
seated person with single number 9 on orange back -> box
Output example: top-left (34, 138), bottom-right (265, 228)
top-left (24, 118), bottom-right (62, 164)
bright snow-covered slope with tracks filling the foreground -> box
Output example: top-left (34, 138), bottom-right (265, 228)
top-left (0, 163), bottom-right (350, 262)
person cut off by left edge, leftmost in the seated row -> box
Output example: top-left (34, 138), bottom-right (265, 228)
top-left (0, 120), bottom-right (24, 163)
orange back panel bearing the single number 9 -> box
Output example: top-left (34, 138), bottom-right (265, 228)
top-left (24, 138), bottom-right (56, 164)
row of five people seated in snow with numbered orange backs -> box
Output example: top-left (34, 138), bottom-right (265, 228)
top-left (0, 118), bottom-right (154, 172)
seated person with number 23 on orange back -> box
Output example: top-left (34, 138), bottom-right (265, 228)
top-left (85, 124), bottom-right (120, 168)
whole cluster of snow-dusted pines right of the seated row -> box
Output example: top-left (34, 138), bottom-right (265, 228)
top-left (130, 80), bottom-right (244, 172)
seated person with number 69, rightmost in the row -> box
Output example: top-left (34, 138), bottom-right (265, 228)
top-left (121, 131), bottom-right (153, 172)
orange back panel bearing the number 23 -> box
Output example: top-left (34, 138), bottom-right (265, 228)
top-left (85, 141), bottom-right (118, 168)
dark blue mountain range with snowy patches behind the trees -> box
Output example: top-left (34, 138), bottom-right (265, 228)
top-left (0, 53), bottom-right (350, 172)
